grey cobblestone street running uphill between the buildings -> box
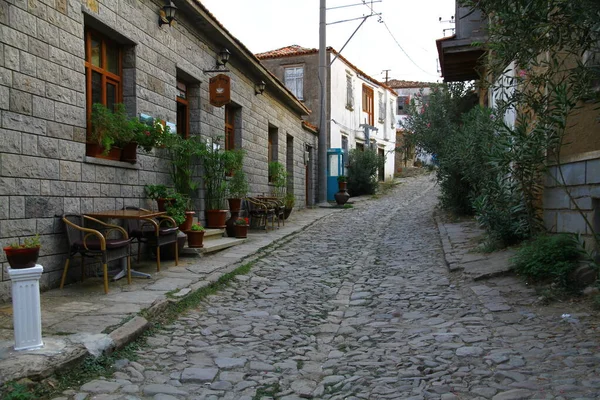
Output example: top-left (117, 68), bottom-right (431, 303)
top-left (54, 177), bottom-right (600, 400)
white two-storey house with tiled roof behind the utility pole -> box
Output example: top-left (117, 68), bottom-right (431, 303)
top-left (257, 45), bottom-right (396, 181)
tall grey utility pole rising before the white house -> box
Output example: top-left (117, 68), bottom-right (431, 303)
top-left (317, 0), bottom-right (328, 204)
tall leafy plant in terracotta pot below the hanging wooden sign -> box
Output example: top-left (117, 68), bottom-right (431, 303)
top-left (202, 142), bottom-right (237, 229)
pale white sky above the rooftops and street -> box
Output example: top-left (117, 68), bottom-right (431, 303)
top-left (201, 0), bottom-right (455, 82)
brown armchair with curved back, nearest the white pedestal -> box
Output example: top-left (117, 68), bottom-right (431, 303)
top-left (60, 214), bottom-right (131, 293)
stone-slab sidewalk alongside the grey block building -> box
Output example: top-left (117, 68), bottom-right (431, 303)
top-left (0, 203), bottom-right (356, 384)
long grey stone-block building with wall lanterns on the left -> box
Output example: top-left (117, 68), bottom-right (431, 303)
top-left (0, 0), bottom-right (317, 298)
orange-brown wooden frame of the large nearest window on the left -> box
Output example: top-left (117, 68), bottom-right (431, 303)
top-left (84, 28), bottom-right (123, 134)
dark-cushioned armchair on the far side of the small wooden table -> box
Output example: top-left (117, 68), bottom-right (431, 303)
top-left (124, 207), bottom-right (179, 271)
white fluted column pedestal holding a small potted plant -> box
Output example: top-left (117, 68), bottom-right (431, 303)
top-left (8, 264), bottom-right (44, 350)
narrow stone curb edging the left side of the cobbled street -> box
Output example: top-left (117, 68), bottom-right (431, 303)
top-left (0, 209), bottom-right (343, 385)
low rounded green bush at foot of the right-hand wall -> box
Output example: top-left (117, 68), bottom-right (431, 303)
top-left (511, 234), bottom-right (582, 289)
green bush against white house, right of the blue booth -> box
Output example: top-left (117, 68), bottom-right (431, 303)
top-left (348, 149), bottom-right (385, 196)
